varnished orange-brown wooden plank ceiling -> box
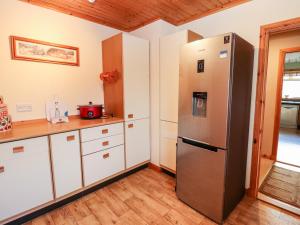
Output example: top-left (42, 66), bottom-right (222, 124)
top-left (21, 0), bottom-right (249, 31)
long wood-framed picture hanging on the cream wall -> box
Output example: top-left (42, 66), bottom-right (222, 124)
top-left (11, 36), bottom-right (79, 66)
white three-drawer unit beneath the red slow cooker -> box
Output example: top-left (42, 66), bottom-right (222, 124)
top-left (81, 123), bottom-right (125, 186)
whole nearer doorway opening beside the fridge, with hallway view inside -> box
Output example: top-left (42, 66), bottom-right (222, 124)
top-left (257, 29), bottom-right (300, 214)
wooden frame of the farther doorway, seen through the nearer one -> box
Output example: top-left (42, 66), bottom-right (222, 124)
top-left (271, 47), bottom-right (300, 160)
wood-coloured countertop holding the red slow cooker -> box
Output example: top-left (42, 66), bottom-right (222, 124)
top-left (0, 116), bottom-right (124, 143)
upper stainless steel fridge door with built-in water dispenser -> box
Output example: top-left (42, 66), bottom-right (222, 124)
top-left (178, 34), bottom-right (232, 148)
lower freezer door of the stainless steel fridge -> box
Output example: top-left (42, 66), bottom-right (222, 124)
top-left (176, 138), bottom-right (227, 223)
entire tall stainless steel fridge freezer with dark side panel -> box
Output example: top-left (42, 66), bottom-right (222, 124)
top-left (176, 33), bottom-right (254, 223)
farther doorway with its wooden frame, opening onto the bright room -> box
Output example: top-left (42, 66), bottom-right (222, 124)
top-left (272, 48), bottom-right (300, 167)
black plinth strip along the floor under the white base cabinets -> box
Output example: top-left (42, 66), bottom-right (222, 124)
top-left (0, 162), bottom-right (148, 225)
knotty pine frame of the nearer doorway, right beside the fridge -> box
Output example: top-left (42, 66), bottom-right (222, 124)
top-left (248, 17), bottom-right (300, 198)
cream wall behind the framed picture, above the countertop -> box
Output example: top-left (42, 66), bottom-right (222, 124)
top-left (0, 0), bottom-right (120, 121)
